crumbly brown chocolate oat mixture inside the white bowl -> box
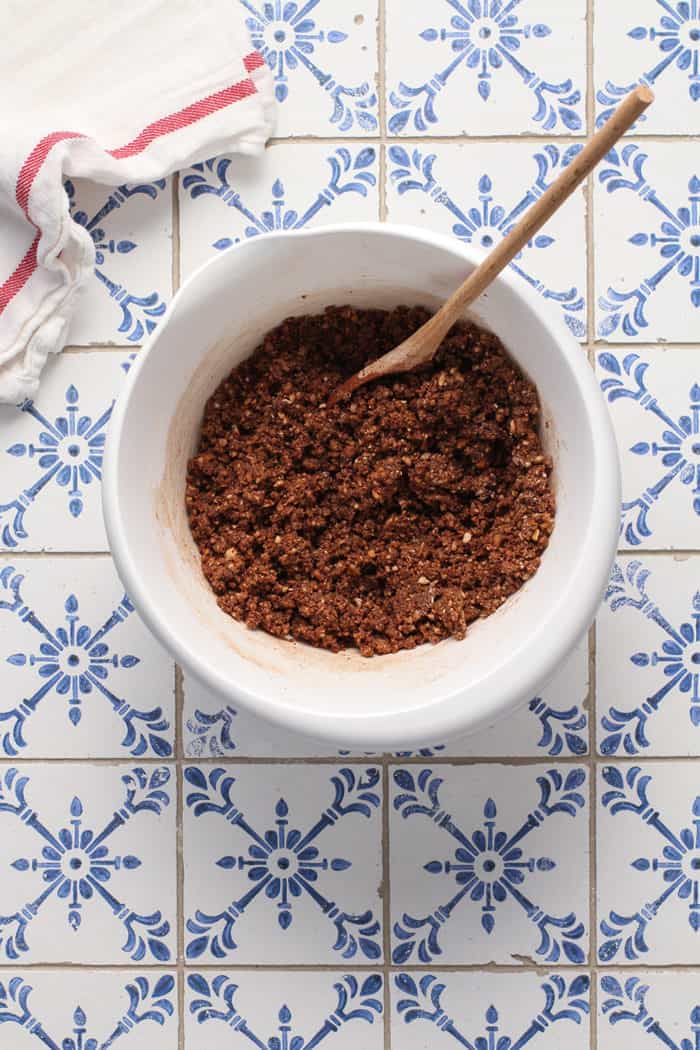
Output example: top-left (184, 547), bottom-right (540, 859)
top-left (187, 307), bottom-right (554, 656)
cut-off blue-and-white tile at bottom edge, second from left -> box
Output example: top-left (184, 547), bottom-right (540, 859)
top-left (185, 969), bottom-right (384, 1050)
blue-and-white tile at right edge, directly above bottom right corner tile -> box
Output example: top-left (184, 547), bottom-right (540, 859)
top-left (596, 762), bottom-right (700, 966)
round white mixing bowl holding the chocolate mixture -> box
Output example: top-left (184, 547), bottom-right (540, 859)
top-left (103, 224), bottom-right (619, 750)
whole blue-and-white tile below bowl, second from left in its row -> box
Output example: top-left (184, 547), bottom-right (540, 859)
top-left (184, 764), bottom-right (382, 965)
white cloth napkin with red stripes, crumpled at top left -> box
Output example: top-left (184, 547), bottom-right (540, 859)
top-left (0, 0), bottom-right (273, 403)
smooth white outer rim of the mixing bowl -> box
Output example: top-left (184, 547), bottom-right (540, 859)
top-left (102, 222), bottom-right (620, 750)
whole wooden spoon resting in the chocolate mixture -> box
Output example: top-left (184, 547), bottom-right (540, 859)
top-left (328, 87), bottom-right (654, 405)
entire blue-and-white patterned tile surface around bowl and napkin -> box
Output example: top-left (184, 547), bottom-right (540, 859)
top-left (0, 0), bottom-right (700, 1050)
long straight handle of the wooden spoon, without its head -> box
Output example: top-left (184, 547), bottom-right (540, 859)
top-left (432, 87), bottom-right (654, 334)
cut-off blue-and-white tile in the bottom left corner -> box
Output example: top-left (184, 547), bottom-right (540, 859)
top-left (0, 969), bottom-right (177, 1050)
